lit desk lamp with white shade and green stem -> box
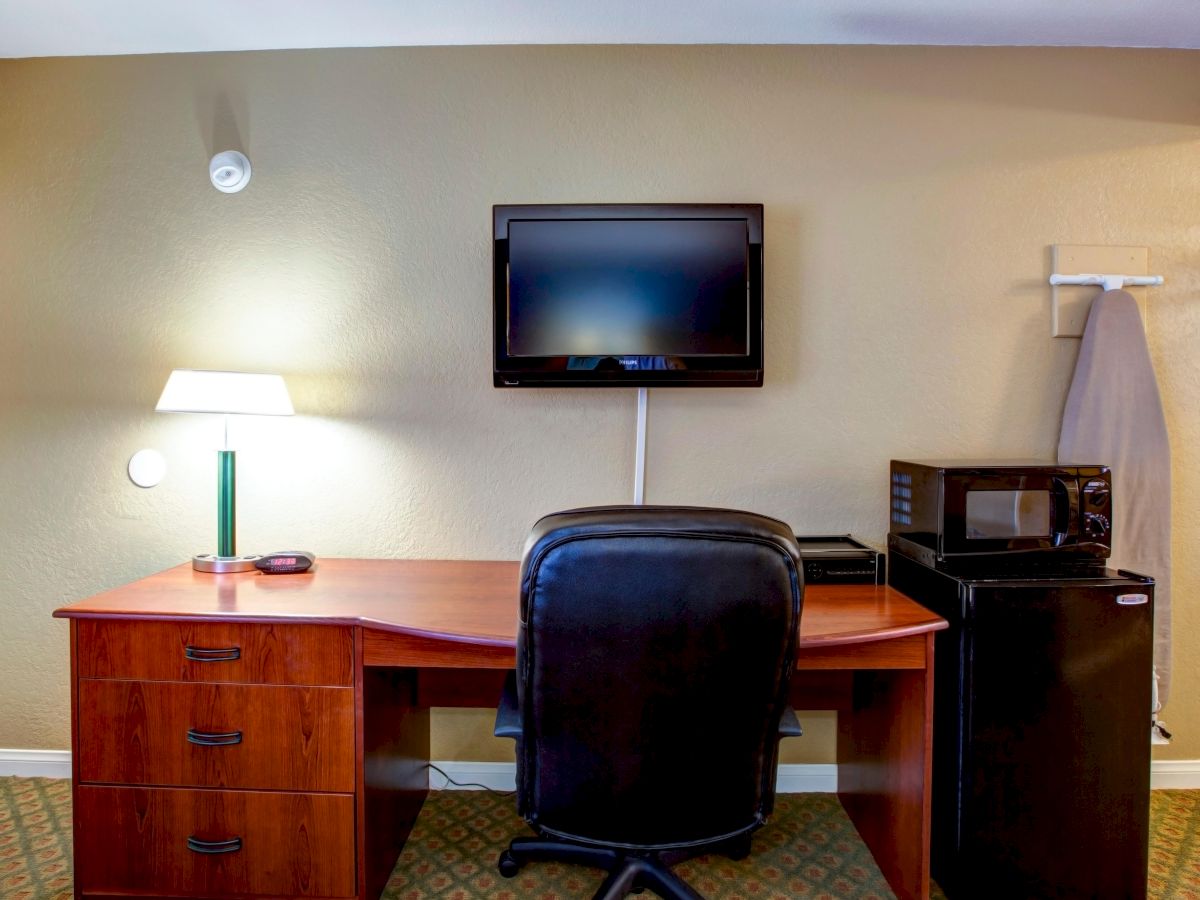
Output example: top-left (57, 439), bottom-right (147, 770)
top-left (155, 368), bottom-right (295, 572)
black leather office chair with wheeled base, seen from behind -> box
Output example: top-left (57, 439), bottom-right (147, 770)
top-left (496, 506), bottom-right (803, 900)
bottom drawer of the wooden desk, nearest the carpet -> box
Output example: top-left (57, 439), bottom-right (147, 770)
top-left (74, 785), bottom-right (355, 898)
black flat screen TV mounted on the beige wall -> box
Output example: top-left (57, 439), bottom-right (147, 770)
top-left (493, 204), bottom-right (762, 388)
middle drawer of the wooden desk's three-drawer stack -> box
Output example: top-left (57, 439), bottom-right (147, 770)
top-left (78, 678), bottom-right (354, 793)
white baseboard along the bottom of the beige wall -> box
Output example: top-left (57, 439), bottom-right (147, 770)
top-left (9, 750), bottom-right (1200, 793)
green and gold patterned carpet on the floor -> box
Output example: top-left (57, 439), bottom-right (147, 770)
top-left (0, 778), bottom-right (1200, 900)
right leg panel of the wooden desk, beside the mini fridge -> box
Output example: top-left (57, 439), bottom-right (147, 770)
top-left (838, 635), bottom-right (934, 900)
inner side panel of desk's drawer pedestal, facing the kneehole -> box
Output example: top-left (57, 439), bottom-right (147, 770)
top-left (358, 643), bottom-right (430, 900)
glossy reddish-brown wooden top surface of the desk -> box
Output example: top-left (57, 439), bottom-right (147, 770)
top-left (54, 559), bottom-right (946, 652)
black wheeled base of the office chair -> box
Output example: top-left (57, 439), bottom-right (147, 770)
top-left (497, 834), bottom-right (750, 900)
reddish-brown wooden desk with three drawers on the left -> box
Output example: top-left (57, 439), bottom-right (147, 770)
top-left (54, 559), bottom-right (946, 900)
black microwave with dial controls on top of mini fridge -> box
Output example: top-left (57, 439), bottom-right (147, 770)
top-left (888, 460), bottom-right (1112, 572)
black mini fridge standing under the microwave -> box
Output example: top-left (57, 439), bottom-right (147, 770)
top-left (888, 551), bottom-right (1153, 900)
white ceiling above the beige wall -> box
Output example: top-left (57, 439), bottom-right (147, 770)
top-left (0, 0), bottom-right (1200, 56)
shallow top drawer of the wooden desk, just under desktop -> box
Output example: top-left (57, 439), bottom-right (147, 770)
top-left (76, 619), bottom-right (354, 686)
